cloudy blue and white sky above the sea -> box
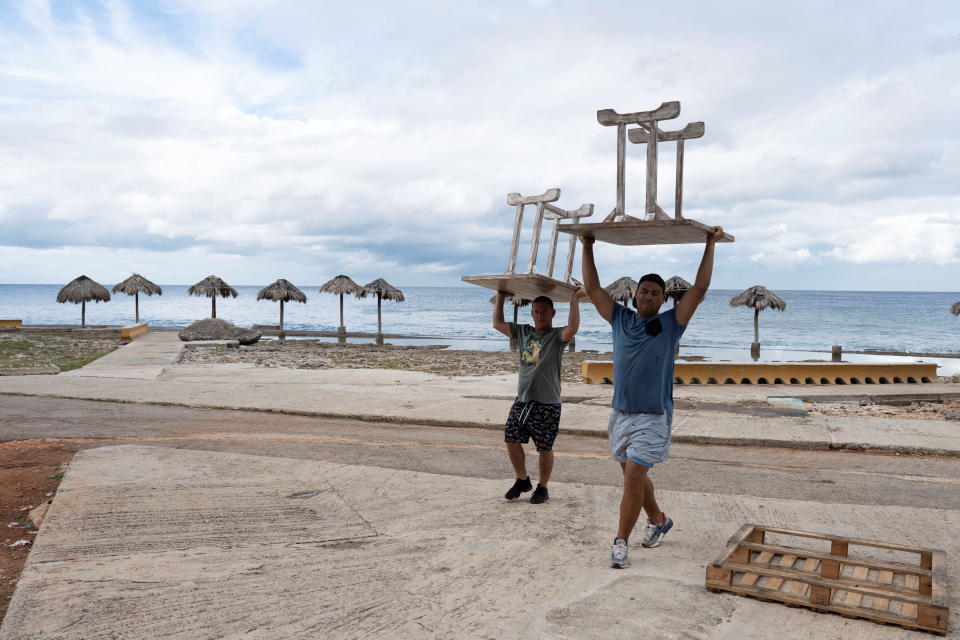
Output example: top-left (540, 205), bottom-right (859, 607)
top-left (0, 0), bottom-right (960, 291)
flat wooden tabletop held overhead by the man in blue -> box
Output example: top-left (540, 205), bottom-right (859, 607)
top-left (559, 218), bottom-right (734, 246)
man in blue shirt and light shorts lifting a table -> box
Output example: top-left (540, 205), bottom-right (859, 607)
top-left (581, 227), bottom-right (723, 568)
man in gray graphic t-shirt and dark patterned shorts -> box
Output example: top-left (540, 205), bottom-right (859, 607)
top-left (493, 287), bottom-right (586, 504)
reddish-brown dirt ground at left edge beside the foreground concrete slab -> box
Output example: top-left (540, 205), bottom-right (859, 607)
top-left (0, 441), bottom-right (77, 622)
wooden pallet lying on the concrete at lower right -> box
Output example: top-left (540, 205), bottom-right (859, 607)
top-left (706, 524), bottom-right (949, 635)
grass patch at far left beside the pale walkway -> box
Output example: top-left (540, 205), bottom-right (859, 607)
top-left (0, 333), bottom-right (119, 371)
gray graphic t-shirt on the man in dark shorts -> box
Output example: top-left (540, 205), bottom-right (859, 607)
top-left (510, 322), bottom-right (567, 404)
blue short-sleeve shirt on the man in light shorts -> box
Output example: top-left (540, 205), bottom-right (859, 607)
top-left (610, 303), bottom-right (686, 423)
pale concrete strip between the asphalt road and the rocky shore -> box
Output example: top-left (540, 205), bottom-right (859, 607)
top-left (0, 332), bottom-right (960, 456)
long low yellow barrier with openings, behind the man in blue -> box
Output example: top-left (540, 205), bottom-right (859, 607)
top-left (582, 360), bottom-right (937, 384)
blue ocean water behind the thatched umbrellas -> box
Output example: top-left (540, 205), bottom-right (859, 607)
top-left (0, 283), bottom-right (960, 360)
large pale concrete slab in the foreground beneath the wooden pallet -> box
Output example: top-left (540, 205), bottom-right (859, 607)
top-left (0, 446), bottom-right (960, 640)
